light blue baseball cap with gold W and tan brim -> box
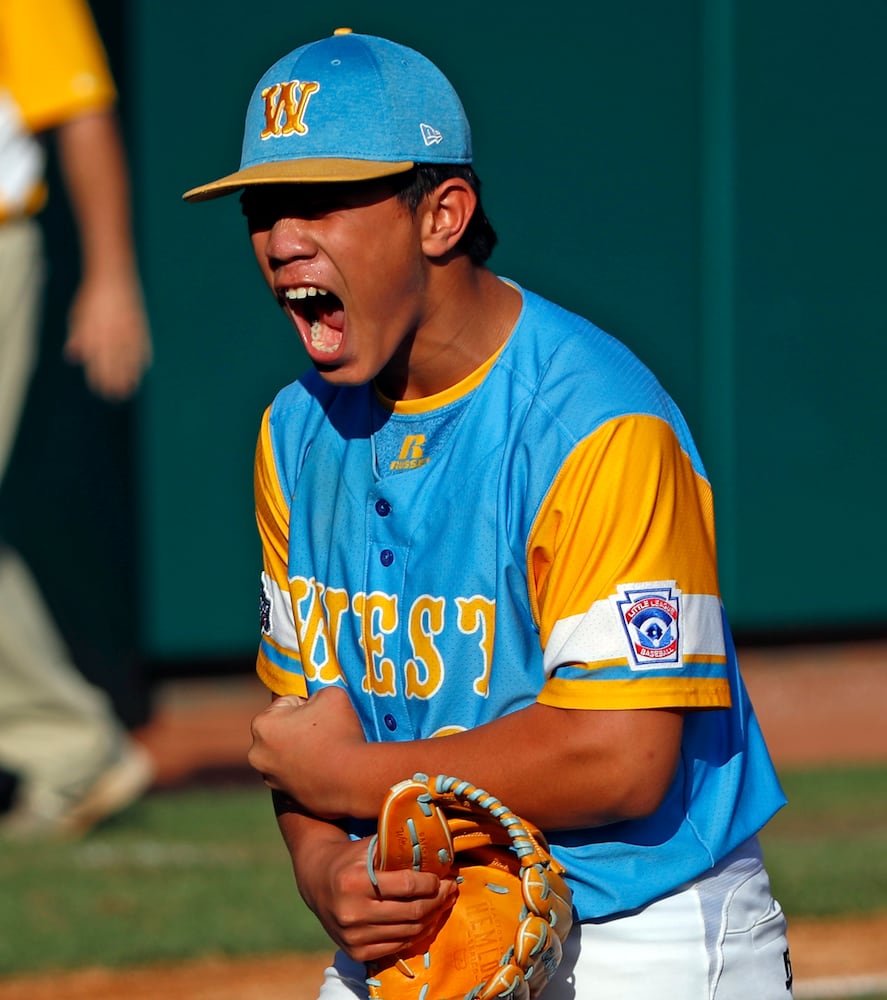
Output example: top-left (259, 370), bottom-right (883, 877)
top-left (184, 28), bottom-right (471, 201)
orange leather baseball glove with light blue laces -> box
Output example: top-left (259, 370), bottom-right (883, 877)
top-left (367, 774), bottom-right (573, 1000)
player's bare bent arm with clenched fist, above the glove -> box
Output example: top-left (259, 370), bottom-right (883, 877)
top-left (250, 689), bottom-right (682, 830)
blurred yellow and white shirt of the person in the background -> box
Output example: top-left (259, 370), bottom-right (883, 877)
top-left (0, 0), bottom-right (117, 221)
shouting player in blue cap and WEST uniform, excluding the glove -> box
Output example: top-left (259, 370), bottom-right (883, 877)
top-left (185, 30), bottom-right (791, 1000)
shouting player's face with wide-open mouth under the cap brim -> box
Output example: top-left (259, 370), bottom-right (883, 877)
top-left (241, 181), bottom-right (425, 385)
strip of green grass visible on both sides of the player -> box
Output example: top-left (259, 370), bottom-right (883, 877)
top-left (0, 768), bottom-right (887, 984)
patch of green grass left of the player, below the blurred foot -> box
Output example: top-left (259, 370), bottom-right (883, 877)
top-left (0, 788), bottom-right (329, 975)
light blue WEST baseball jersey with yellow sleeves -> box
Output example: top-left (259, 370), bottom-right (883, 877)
top-left (256, 291), bottom-right (784, 919)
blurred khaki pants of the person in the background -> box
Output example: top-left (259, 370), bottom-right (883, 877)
top-left (0, 220), bottom-right (124, 817)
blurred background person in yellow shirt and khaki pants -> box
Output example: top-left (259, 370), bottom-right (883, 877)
top-left (0, 0), bottom-right (154, 836)
